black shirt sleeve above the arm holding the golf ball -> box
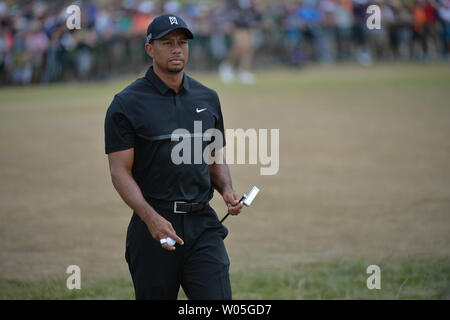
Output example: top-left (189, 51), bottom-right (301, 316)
top-left (105, 95), bottom-right (135, 154)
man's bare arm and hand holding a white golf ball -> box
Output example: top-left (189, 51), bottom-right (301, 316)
top-left (108, 148), bottom-right (183, 250)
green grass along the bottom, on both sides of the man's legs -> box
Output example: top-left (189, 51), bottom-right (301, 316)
top-left (0, 258), bottom-right (450, 300)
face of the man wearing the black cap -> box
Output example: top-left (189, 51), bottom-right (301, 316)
top-left (145, 29), bottom-right (189, 73)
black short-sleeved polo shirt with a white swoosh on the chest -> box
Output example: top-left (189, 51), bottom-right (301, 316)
top-left (105, 67), bottom-right (225, 202)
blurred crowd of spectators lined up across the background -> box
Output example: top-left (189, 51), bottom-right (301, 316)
top-left (0, 0), bottom-right (450, 85)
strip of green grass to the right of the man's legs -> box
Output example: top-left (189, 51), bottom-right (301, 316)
top-left (229, 259), bottom-right (450, 299)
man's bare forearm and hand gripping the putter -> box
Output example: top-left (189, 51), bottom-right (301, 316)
top-left (208, 149), bottom-right (244, 215)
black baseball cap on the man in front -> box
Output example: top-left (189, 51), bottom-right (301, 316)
top-left (147, 14), bottom-right (194, 43)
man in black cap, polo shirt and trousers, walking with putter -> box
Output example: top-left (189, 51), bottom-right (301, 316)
top-left (105, 15), bottom-right (242, 299)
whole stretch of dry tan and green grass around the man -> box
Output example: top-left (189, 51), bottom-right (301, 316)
top-left (0, 64), bottom-right (450, 299)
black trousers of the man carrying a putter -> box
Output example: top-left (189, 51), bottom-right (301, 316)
top-left (125, 202), bottom-right (231, 300)
